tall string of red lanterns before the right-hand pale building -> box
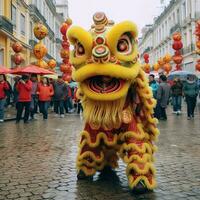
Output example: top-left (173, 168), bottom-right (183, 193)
top-left (172, 32), bottom-right (183, 70)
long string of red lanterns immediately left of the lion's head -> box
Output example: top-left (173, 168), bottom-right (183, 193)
top-left (60, 18), bottom-right (72, 82)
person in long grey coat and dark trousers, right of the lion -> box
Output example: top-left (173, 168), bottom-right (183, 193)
top-left (156, 75), bottom-right (170, 120)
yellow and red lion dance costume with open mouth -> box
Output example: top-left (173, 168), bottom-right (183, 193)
top-left (68, 12), bottom-right (159, 190)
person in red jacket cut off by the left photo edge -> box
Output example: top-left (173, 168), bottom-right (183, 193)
top-left (0, 74), bottom-right (9, 122)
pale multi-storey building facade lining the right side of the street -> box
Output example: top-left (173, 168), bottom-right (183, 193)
top-left (139, 0), bottom-right (200, 72)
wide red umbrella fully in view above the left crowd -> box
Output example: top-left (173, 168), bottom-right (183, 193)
top-left (11, 65), bottom-right (54, 75)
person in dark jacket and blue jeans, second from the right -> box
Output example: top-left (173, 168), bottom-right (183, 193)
top-left (171, 78), bottom-right (183, 115)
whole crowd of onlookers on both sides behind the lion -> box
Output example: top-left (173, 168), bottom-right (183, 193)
top-left (0, 74), bottom-right (199, 123)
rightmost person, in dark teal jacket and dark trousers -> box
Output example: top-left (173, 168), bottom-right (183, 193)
top-left (183, 76), bottom-right (199, 120)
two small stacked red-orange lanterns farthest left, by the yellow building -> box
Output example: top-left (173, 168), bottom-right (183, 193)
top-left (12, 42), bottom-right (24, 68)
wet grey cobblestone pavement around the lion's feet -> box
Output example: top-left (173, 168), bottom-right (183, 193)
top-left (0, 105), bottom-right (200, 200)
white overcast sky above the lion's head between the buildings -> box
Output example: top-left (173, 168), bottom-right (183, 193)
top-left (68, 0), bottom-right (169, 35)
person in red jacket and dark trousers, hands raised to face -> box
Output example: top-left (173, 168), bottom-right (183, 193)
top-left (16, 75), bottom-right (32, 123)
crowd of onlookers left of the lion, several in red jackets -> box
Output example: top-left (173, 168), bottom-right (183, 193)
top-left (0, 74), bottom-right (82, 123)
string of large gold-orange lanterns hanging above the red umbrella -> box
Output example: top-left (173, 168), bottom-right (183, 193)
top-left (33, 22), bottom-right (49, 68)
